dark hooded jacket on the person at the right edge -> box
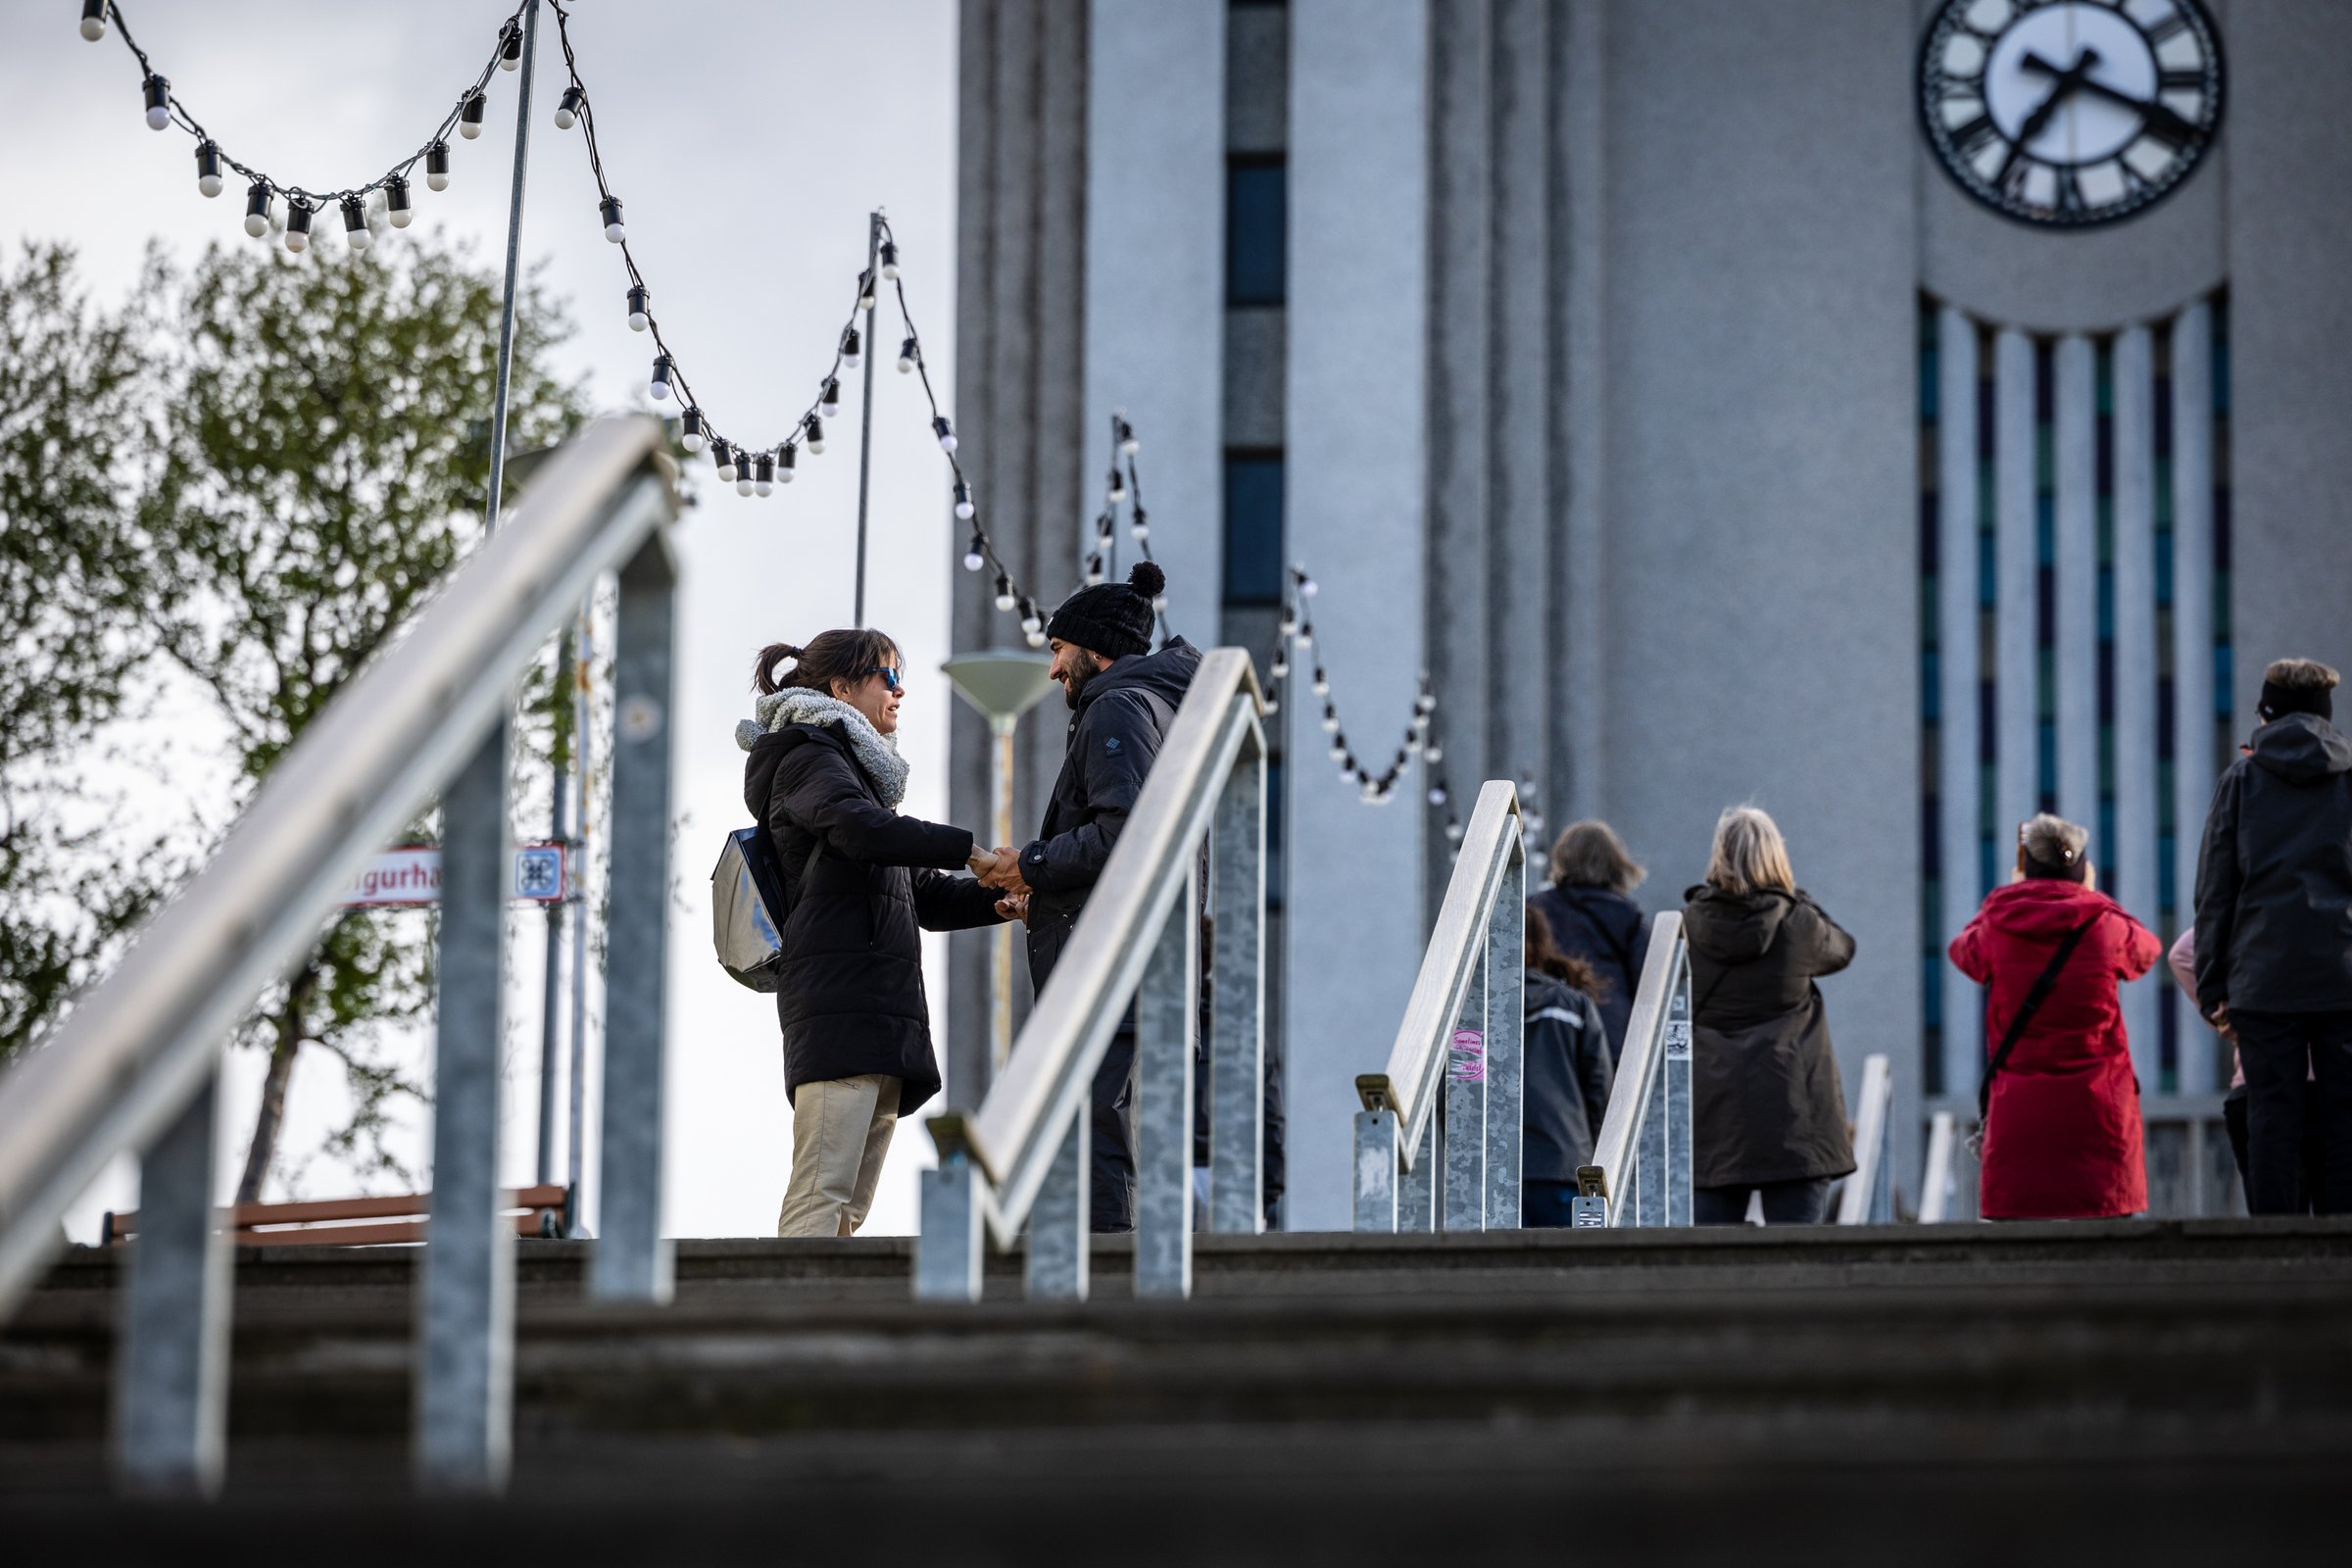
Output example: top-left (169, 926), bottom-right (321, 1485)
top-left (2197, 712), bottom-right (2352, 1018)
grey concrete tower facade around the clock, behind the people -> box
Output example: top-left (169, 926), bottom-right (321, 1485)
top-left (955, 0), bottom-right (2352, 1227)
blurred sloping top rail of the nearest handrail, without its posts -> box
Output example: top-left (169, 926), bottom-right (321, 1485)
top-left (0, 416), bottom-right (675, 1316)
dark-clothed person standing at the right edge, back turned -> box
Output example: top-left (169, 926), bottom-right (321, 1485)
top-left (2197, 659), bottom-right (2352, 1213)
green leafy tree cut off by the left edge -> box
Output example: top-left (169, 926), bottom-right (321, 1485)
top-left (0, 244), bottom-right (176, 1060)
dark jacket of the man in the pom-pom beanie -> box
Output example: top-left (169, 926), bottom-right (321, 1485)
top-left (1021, 637), bottom-right (1200, 990)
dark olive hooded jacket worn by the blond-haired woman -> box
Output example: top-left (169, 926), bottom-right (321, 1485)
top-left (1682, 886), bottom-right (1853, 1187)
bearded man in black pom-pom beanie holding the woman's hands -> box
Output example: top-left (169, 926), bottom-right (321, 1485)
top-left (983, 562), bottom-right (1200, 1232)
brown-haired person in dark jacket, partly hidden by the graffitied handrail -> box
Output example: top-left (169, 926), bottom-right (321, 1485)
top-left (1519, 901), bottom-right (1616, 1230)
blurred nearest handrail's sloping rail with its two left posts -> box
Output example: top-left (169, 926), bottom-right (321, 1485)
top-left (0, 416), bottom-right (677, 1491)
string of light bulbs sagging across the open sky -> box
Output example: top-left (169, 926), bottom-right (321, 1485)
top-left (82, 0), bottom-right (1045, 647)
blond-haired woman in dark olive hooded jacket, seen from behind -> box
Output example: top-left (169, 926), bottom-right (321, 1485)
top-left (1682, 807), bottom-right (1853, 1225)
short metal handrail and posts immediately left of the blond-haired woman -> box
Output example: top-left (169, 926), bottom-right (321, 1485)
top-left (1576, 909), bottom-right (1691, 1225)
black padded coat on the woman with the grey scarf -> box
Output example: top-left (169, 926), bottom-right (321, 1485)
top-left (743, 724), bottom-right (998, 1116)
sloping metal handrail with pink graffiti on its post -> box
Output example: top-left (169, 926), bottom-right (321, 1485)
top-left (1354, 778), bottom-right (1527, 1232)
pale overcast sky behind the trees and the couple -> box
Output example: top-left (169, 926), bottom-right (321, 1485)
top-left (0, 0), bottom-right (964, 1237)
